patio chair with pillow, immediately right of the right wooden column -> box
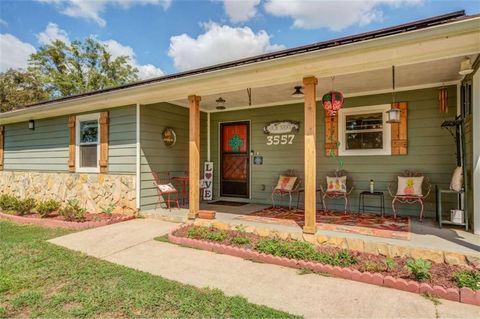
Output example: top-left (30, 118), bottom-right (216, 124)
top-left (320, 170), bottom-right (354, 212)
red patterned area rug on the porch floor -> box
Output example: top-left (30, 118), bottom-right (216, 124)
top-left (236, 208), bottom-right (410, 240)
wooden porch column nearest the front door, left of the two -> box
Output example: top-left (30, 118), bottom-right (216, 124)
top-left (188, 95), bottom-right (201, 219)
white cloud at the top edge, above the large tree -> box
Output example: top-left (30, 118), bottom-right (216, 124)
top-left (37, 0), bottom-right (172, 27)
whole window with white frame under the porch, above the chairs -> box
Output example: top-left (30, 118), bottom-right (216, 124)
top-left (338, 104), bottom-right (391, 156)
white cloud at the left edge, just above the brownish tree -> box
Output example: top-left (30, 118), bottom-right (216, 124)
top-left (0, 33), bottom-right (36, 72)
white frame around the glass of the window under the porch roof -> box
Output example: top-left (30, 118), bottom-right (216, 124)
top-left (338, 104), bottom-right (392, 156)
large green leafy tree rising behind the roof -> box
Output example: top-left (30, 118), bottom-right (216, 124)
top-left (28, 38), bottom-right (138, 97)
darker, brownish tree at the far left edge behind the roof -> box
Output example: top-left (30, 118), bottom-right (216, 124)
top-left (0, 69), bottom-right (48, 112)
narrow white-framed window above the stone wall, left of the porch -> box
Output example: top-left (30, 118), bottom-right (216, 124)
top-left (76, 113), bottom-right (100, 173)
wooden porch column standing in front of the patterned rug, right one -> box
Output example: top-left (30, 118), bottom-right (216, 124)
top-left (303, 76), bottom-right (318, 234)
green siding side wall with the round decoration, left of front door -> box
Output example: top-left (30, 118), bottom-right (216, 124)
top-left (140, 103), bottom-right (207, 210)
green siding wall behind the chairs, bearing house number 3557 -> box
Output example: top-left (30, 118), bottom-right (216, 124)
top-left (211, 86), bottom-right (456, 216)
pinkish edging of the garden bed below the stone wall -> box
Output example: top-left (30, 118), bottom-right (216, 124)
top-left (0, 212), bottom-right (135, 230)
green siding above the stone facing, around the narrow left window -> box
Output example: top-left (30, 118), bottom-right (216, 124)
top-left (4, 106), bottom-right (136, 174)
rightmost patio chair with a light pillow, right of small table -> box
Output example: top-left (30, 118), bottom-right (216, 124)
top-left (388, 170), bottom-right (432, 221)
